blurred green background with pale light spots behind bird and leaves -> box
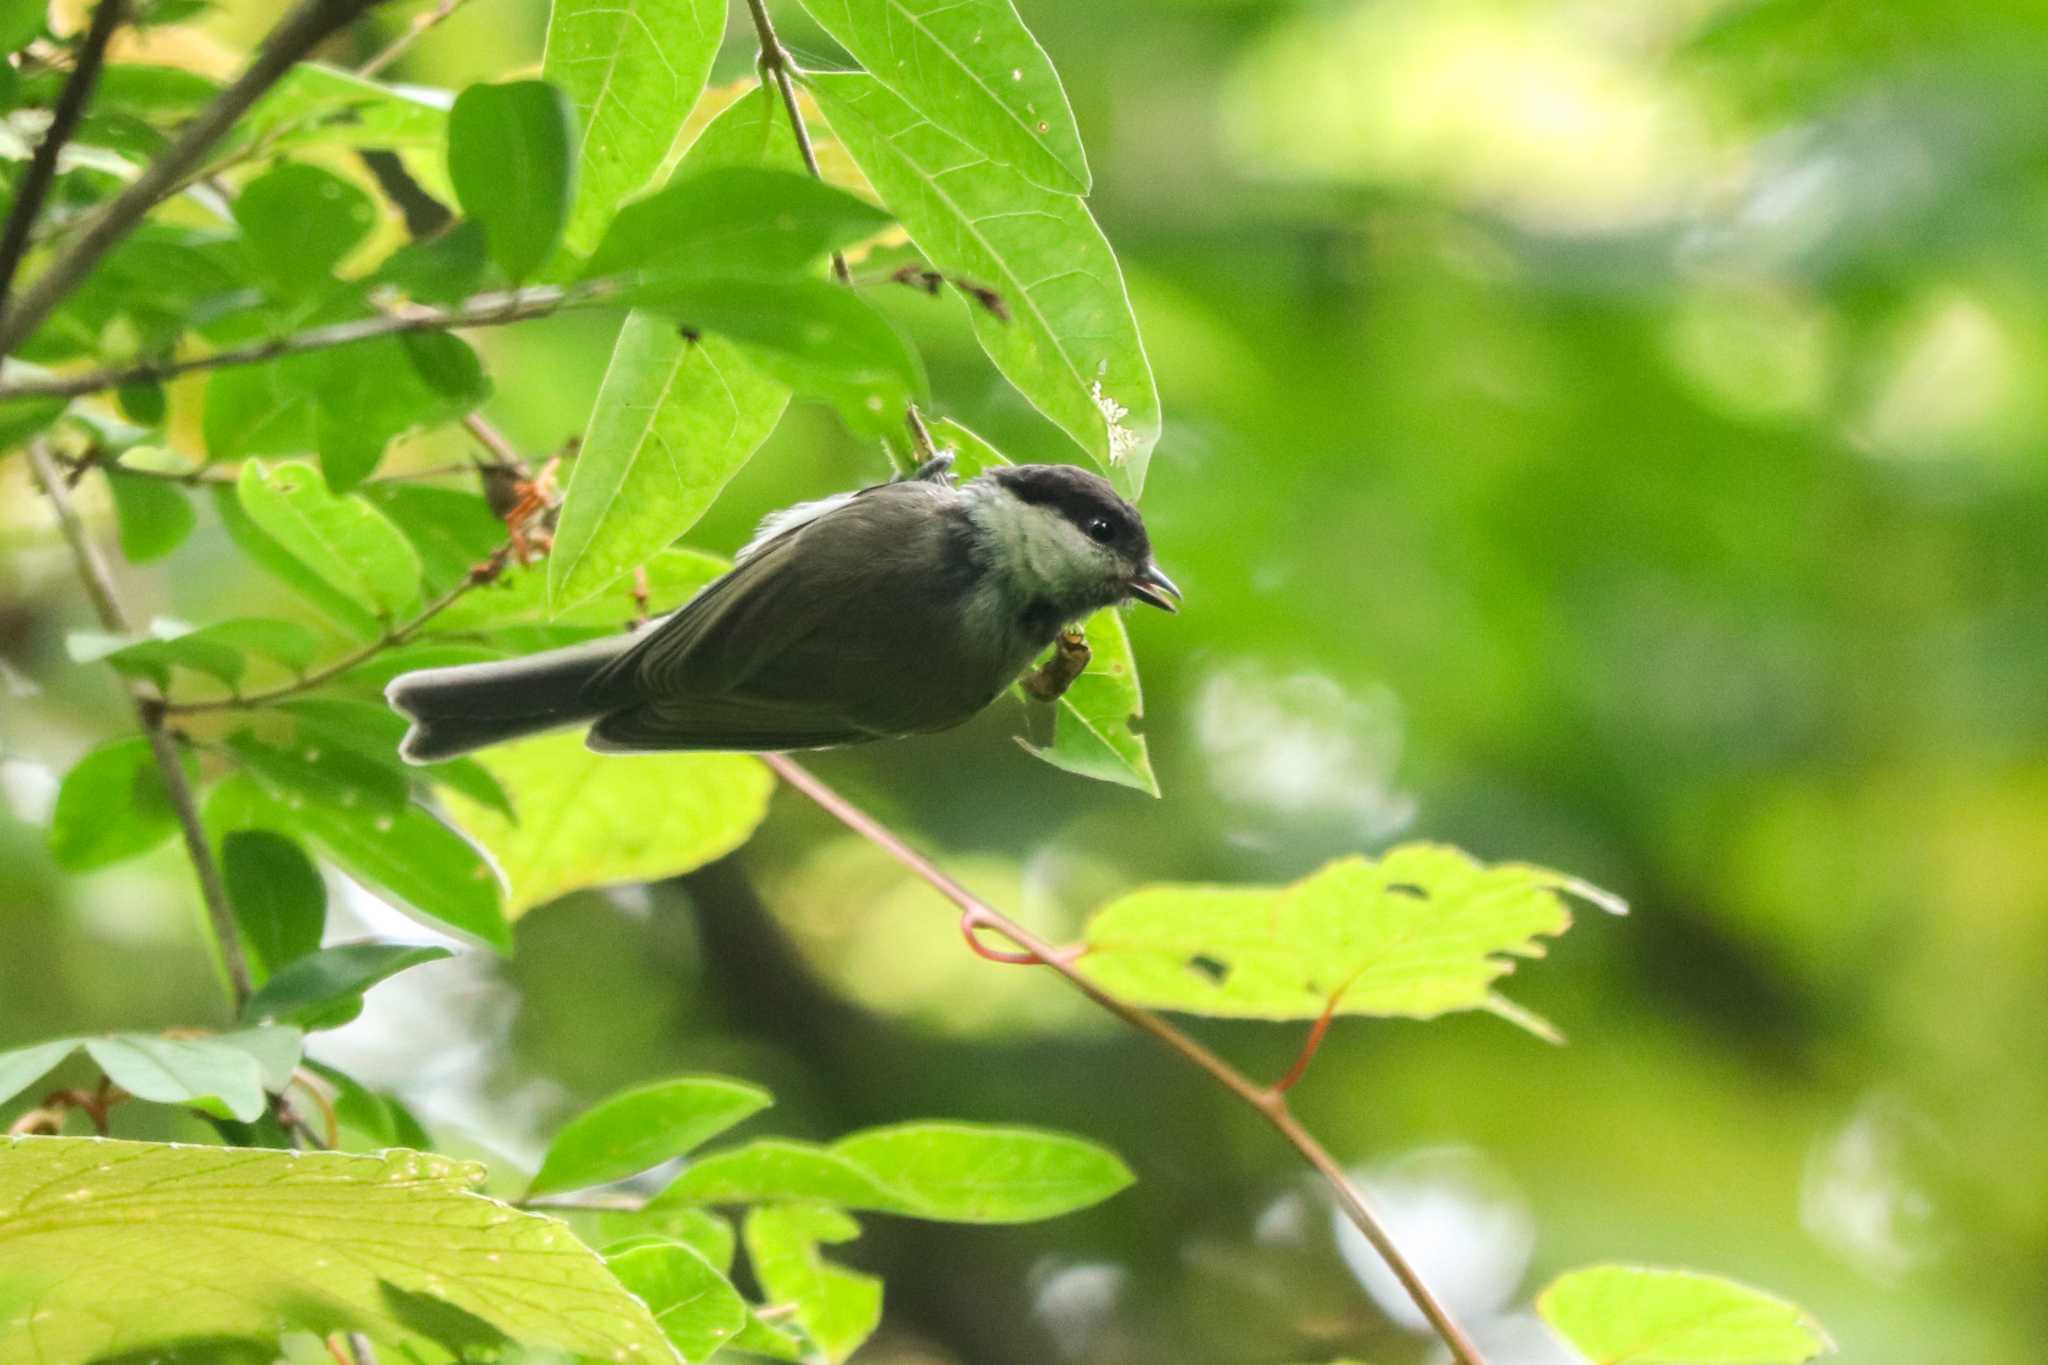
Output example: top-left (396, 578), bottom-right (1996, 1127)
top-left (0, 0), bottom-right (2048, 1365)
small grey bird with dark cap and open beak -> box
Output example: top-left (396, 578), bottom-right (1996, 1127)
top-left (385, 454), bottom-right (1180, 763)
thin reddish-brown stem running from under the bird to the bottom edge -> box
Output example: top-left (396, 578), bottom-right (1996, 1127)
top-left (762, 753), bottom-right (1485, 1365)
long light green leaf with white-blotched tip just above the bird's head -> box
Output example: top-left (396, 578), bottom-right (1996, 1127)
top-left (811, 72), bottom-right (1159, 497)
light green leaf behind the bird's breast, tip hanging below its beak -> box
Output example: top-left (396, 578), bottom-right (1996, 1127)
top-left (932, 417), bottom-right (1159, 796)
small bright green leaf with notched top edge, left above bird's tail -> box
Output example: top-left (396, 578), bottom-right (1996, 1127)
top-left (236, 460), bottom-right (420, 620)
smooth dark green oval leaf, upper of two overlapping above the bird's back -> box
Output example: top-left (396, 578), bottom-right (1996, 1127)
top-left (584, 166), bottom-right (889, 276)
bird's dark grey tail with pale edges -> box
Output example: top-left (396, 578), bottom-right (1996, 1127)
top-left (385, 634), bottom-right (637, 763)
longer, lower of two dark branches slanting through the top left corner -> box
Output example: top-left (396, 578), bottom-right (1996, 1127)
top-left (0, 0), bottom-right (383, 356)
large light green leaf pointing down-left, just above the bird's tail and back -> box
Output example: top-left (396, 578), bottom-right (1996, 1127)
top-left (547, 311), bottom-right (788, 608)
